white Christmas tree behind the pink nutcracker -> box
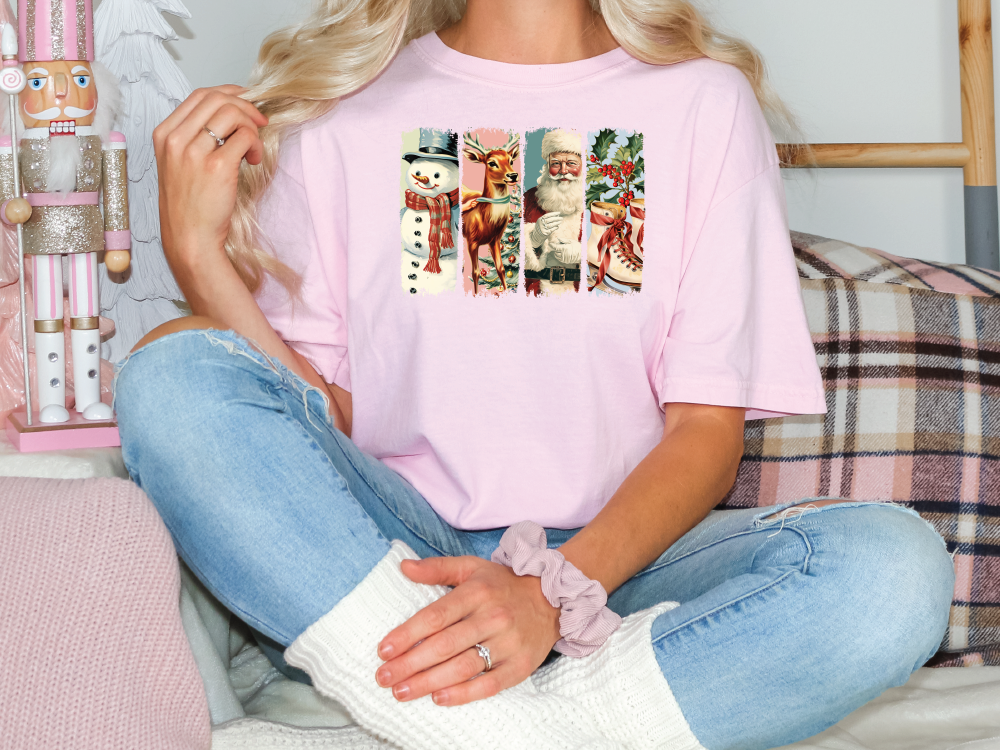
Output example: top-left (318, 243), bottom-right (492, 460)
top-left (94, 0), bottom-right (191, 362)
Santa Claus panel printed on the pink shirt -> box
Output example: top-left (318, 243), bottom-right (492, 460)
top-left (524, 128), bottom-right (585, 296)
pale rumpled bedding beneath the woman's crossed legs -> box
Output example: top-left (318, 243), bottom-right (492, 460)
top-left (181, 570), bottom-right (1000, 750)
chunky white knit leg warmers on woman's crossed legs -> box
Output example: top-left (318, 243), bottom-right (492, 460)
top-left (285, 542), bottom-right (703, 750)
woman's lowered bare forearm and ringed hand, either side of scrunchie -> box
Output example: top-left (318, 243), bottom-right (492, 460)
top-left (377, 404), bottom-right (744, 706)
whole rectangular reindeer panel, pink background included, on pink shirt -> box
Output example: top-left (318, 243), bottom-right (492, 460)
top-left (462, 128), bottom-right (523, 295)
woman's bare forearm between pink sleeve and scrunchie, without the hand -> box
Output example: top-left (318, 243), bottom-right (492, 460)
top-left (559, 404), bottom-right (745, 593)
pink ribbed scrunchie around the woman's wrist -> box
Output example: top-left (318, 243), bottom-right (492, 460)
top-left (491, 521), bottom-right (622, 657)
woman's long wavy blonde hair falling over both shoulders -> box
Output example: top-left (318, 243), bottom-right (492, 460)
top-left (226, 0), bottom-right (796, 296)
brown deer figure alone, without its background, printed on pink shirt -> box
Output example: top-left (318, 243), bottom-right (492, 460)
top-left (462, 133), bottom-right (520, 293)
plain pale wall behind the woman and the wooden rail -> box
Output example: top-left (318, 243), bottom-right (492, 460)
top-left (164, 0), bottom-right (1000, 262)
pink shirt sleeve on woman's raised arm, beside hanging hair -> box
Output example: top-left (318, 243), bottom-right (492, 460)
top-left (257, 136), bottom-right (351, 390)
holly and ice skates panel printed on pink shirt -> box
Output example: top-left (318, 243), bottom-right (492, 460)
top-left (586, 129), bottom-right (646, 295)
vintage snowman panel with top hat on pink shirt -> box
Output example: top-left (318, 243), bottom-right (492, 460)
top-left (399, 128), bottom-right (459, 294)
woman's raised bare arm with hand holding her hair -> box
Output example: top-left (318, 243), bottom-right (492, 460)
top-left (146, 86), bottom-right (350, 434)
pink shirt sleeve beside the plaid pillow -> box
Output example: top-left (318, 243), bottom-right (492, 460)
top-left (658, 164), bottom-right (826, 419)
